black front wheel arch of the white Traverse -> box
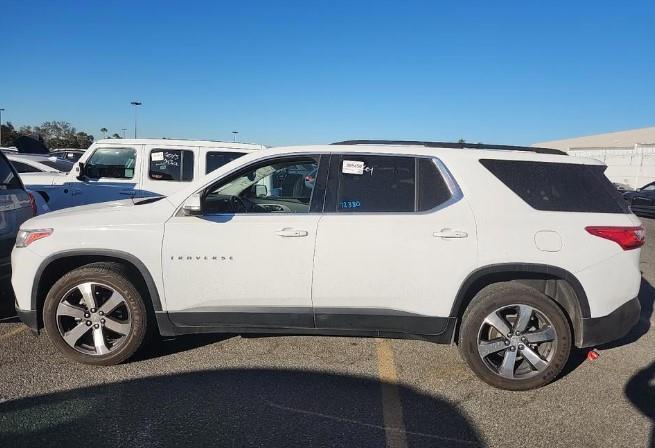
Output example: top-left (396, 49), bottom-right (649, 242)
top-left (31, 249), bottom-right (162, 328)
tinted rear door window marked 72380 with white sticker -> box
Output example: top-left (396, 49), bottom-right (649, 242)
top-left (336, 154), bottom-right (451, 213)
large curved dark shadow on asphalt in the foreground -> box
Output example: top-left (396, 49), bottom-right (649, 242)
top-left (0, 369), bottom-right (487, 447)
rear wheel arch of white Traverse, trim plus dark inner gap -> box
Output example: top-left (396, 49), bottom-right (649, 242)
top-left (450, 263), bottom-right (591, 346)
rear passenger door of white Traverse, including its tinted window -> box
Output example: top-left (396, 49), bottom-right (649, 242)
top-left (312, 154), bottom-right (477, 334)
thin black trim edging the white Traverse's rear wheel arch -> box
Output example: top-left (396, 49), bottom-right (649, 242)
top-left (450, 263), bottom-right (591, 319)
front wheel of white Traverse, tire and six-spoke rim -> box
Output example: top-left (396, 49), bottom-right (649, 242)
top-left (43, 263), bottom-right (147, 365)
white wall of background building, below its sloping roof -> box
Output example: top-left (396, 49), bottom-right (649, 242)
top-left (568, 144), bottom-right (655, 188)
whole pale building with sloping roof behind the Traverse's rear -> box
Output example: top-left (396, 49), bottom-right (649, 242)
top-left (532, 126), bottom-right (655, 188)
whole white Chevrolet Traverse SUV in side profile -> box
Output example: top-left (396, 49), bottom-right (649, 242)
top-left (12, 141), bottom-right (644, 390)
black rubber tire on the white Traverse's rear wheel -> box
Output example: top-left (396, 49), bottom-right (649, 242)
top-left (459, 282), bottom-right (571, 390)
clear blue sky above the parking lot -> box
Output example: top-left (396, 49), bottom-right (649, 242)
top-left (0, 0), bottom-right (655, 145)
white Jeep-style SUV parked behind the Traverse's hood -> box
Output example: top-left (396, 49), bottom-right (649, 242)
top-left (22, 139), bottom-right (264, 210)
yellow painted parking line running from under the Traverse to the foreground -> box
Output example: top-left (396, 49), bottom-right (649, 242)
top-left (376, 339), bottom-right (407, 448)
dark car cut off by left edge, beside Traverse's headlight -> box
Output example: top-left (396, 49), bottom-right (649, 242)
top-left (0, 152), bottom-right (35, 277)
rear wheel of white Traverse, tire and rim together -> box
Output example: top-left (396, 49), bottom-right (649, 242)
top-left (459, 282), bottom-right (571, 390)
